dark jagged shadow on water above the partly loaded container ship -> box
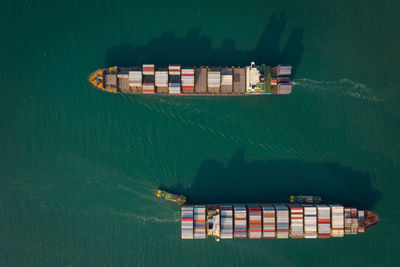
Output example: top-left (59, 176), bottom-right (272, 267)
top-left (105, 12), bottom-right (304, 78)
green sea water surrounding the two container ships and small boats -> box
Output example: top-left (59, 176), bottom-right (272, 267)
top-left (0, 0), bottom-right (400, 266)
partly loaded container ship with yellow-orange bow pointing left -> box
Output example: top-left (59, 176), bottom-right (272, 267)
top-left (88, 62), bottom-right (292, 96)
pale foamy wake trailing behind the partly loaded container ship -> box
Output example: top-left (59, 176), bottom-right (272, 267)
top-left (294, 78), bottom-right (385, 102)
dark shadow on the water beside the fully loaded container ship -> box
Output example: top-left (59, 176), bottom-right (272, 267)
top-left (162, 150), bottom-right (382, 209)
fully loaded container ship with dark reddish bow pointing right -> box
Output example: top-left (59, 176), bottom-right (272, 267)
top-left (181, 197), bottom-right (379, 241)
